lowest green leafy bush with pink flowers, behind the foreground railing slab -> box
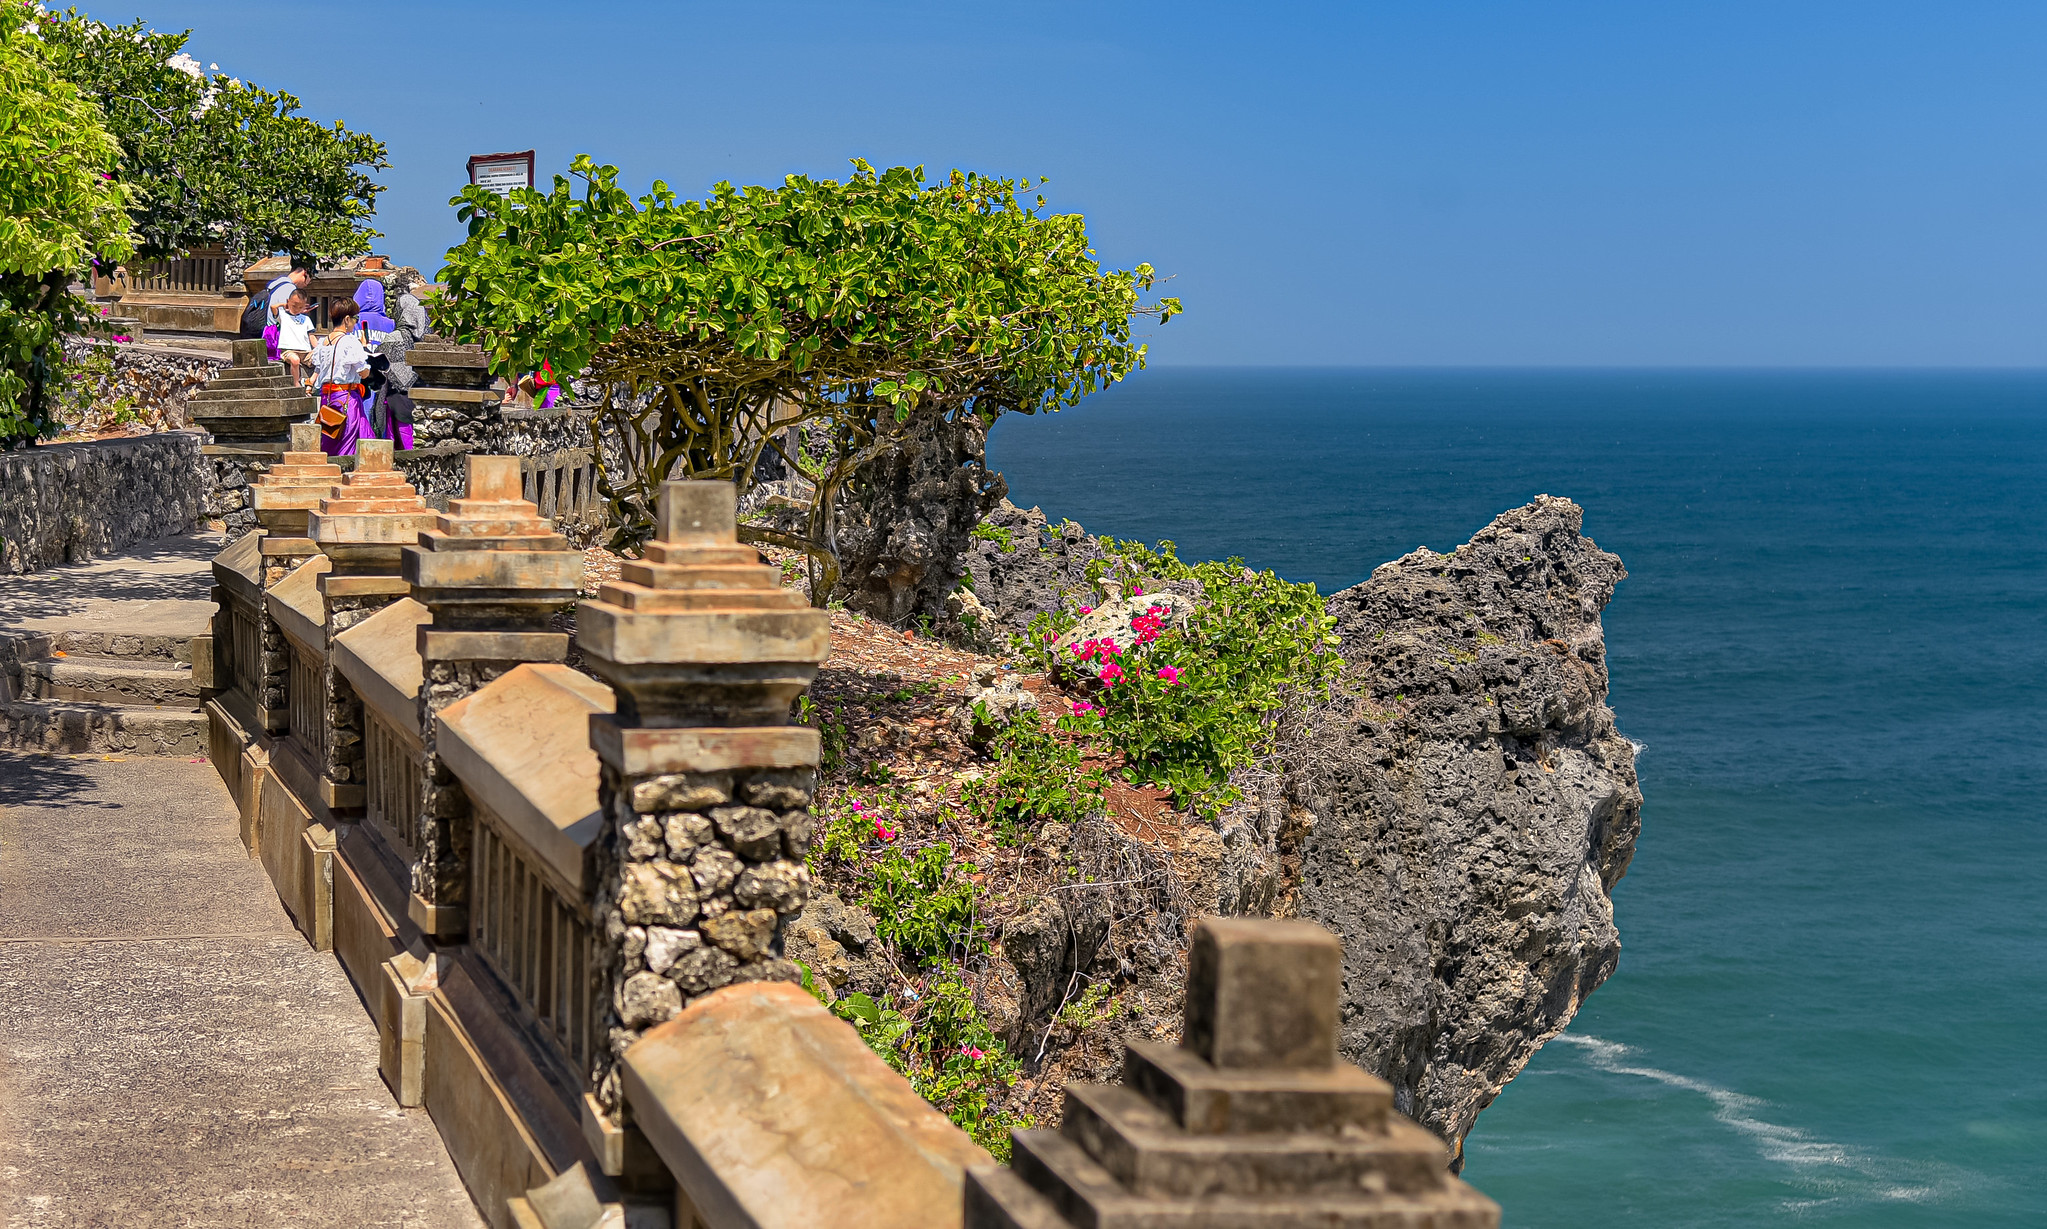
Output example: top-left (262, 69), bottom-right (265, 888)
top-left (831, 967), bottom-right (1032, 1161)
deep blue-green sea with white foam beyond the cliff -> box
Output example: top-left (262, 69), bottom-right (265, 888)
top-left (991, 369), bottom-right (2047, 1229)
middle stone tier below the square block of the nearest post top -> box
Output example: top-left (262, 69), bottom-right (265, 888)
top-left (1060, 1084), bottom-right (1449, 1198)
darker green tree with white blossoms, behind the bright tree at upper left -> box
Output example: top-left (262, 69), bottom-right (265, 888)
top-left (39, 8), bottom-right (389, 262)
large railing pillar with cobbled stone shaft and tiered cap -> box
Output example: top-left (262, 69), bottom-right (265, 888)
top-left (577, 481), bottom-right (831, 1127)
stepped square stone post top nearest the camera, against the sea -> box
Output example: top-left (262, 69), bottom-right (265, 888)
top-left (966, 918), bottom-right (1500, 1229)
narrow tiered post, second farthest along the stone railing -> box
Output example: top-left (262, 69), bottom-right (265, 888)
top-left (307, 440), bottom-right (436, 813)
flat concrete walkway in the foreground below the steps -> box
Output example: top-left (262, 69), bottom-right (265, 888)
top-left (0, 754), bottom-right (483, 1229)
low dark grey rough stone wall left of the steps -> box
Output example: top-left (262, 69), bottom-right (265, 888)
top-left (0, 430), bottom-right (213, 571)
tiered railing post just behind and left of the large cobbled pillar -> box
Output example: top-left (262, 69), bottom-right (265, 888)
top-left (401, 457), bottom-right (583, 940)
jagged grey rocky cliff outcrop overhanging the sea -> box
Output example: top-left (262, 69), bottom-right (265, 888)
top-left (1285, 496), bottom-right (1642, 1161)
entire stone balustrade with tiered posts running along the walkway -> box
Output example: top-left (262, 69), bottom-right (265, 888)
top-left (207, 458), bottom-right (1496, 1229)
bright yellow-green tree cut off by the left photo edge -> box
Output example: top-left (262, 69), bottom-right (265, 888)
top-left (0, 2), bottom-right (129, 447)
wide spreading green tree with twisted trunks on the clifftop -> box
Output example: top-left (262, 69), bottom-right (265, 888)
top-left (436, 156), bottom-right (1179, 602)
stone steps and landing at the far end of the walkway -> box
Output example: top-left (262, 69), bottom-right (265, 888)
top-left (0, 533), bottom-right (223, 756)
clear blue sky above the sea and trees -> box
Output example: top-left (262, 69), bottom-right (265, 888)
top-left (88, 0), bottom-right (2047, 367)
